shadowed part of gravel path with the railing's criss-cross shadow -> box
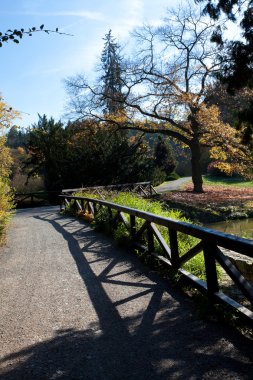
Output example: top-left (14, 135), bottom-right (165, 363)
top-left (0, 212), bottom-right (253, 380)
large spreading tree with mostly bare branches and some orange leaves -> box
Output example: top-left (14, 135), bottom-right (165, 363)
top-left (65, 6), bottom-right (251, 192)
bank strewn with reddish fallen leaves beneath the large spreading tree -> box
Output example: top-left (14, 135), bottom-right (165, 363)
top-left (161, 176), bottom-right (253, 223)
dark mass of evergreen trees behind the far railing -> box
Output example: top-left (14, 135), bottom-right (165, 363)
top-left (7, 115), bottom-right (176, 190)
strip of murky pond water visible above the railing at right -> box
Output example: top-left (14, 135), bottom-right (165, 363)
top-left (205, 218), bottom-right (253, 239)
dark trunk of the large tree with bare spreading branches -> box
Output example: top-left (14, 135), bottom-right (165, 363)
top-left (190, 138), bottom-right (204, 193)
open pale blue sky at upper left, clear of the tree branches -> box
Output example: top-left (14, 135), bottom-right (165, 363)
top-left (0, 0), bottom-right (176, 127)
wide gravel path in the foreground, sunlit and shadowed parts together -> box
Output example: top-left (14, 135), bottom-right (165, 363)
top-left (0, 207), bottom-right (253, 380)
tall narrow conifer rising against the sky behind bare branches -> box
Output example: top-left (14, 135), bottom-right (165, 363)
top-left (101, 30), bottom-right (123, 114)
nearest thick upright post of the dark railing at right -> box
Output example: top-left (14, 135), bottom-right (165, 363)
top-left (203, 242), bottom-right (219, 296)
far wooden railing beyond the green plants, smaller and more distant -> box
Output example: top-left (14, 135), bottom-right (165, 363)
top-left (62, 182), bottom-right (157, 199)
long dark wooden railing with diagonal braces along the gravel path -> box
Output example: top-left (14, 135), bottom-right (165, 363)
top-left (60, 195), bottom-right (253, 324)
